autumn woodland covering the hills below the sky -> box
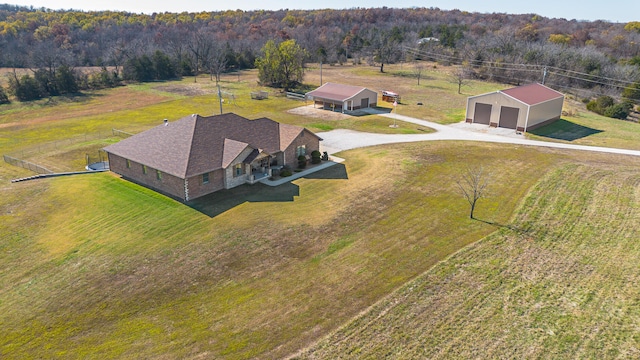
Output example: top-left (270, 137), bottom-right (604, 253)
top-left (0, 5), bottom-right (640, 100)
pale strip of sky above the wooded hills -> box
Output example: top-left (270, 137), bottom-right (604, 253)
top-left (0, 0), bottom-right (640, 23)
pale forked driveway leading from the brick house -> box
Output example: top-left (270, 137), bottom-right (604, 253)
top-left (318, 114), bottom-right (640, 156)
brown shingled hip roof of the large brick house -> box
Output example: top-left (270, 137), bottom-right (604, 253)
top-left (105, 113), bottom-right (316, 178)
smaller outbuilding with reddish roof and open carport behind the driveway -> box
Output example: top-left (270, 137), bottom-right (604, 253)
top-left (306, 83), bottom-right (378, 112)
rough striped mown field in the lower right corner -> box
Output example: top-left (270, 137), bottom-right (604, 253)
top-left (296, 154), bottom-right (640, 359)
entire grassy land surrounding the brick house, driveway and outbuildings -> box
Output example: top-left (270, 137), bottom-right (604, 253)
top-left (0, 64), bottom-right (640, 359)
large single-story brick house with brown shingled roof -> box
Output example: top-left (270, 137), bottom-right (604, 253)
top-left (104, 113), bottom-right (322, 201)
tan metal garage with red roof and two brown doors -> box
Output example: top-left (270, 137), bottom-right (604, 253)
top-left (466, 84), bottom-right (564, 132)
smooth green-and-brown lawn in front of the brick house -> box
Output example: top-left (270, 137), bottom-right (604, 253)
top-left (0, 142), bottom-right (563, 359)
